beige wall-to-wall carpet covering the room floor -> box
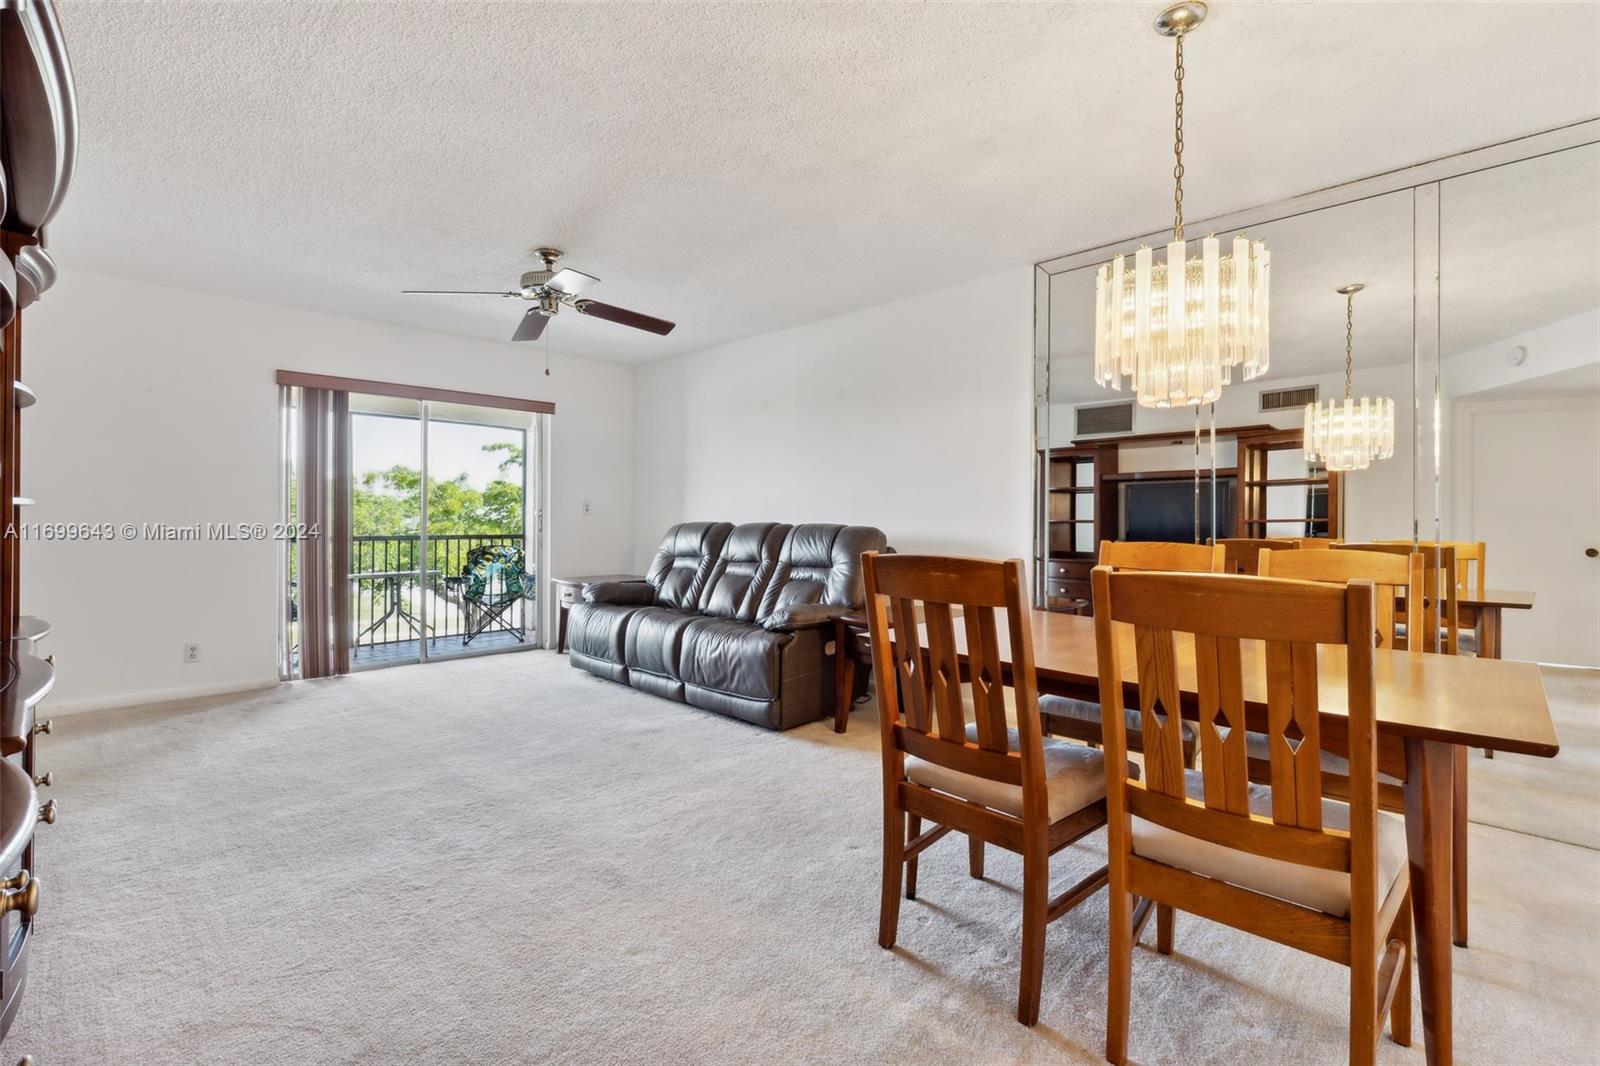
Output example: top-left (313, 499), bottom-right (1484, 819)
top-left (5, 651), bottom-right (1600, 1066)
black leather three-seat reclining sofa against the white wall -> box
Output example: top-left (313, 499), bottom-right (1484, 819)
top-left (566, 522), bottom-right (886, 730)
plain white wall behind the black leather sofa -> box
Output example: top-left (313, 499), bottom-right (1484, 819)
top-left (635, 267), bottom-right (1034, 567)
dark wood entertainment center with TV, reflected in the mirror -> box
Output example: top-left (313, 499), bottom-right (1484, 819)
top-left (1034, 424), bottom-right (1342, 613)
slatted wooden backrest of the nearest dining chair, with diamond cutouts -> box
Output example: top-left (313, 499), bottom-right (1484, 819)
top-left (1091, 567), bottom-right (1378, 901)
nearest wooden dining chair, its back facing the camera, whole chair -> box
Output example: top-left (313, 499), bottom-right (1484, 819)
top-left (1091, 567), bottom-right (1411, 1064)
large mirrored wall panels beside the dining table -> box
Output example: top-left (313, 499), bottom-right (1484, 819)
top-left (1034, 123), bottom-right (1600, 664)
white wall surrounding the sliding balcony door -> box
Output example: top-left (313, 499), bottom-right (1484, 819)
top-left (22, 271), bottom-right (634, 712)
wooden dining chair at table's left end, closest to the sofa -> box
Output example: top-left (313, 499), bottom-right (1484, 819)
top-left (862, 552), bottom-right (1106, 1026)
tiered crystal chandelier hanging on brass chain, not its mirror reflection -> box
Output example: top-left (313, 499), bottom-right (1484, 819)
top-left (1094, 0), bottom-right (1270, 407)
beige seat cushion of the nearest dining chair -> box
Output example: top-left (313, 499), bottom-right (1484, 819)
top-left (1133, 770), bottom-right (1406, 917)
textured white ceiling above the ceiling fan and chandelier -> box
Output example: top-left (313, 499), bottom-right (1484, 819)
top-left (53, 0), bottom-right (1600, 360)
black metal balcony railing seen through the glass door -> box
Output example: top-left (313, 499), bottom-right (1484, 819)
top-left (350, 533), bottom-right (534, 661)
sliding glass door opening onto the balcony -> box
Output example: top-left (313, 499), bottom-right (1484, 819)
top-left (280, 389), bottom-right (544, 677)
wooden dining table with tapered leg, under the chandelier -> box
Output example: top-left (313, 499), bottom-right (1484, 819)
top-left (957, 610), bottom-right (1560, 1063)
